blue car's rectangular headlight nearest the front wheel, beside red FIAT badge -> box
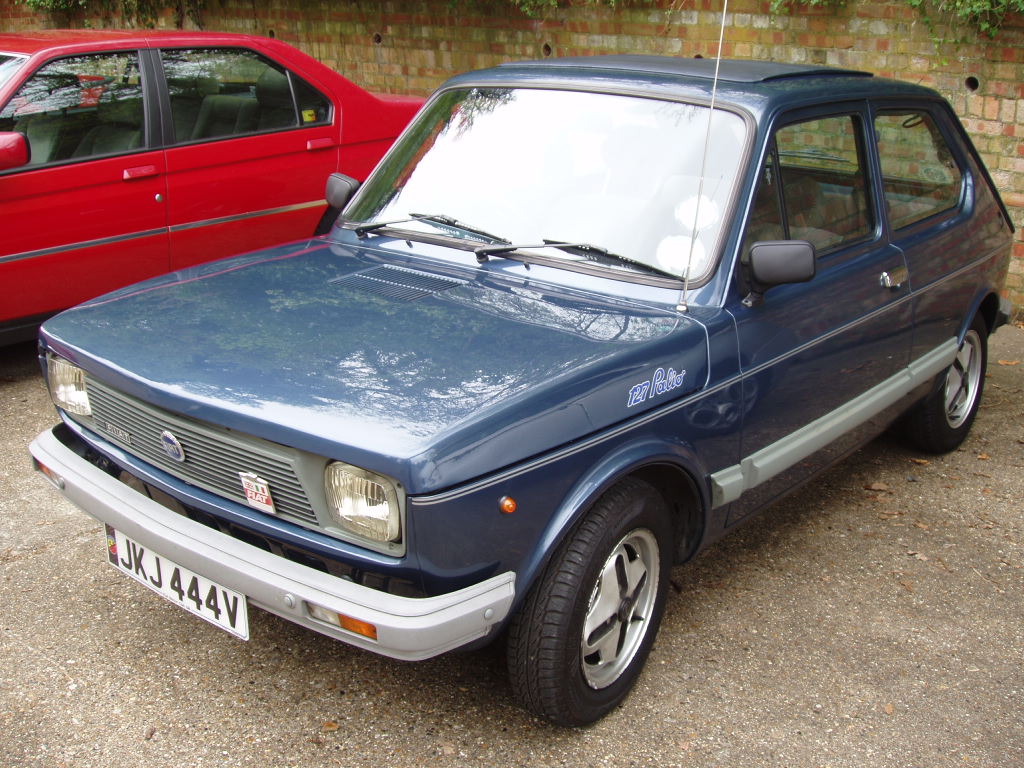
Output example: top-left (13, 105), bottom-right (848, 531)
top-left (324, 462), bottom-right (401, 542)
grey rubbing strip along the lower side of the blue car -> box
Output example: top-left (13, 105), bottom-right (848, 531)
top-left (711, 339), bottom-right (957, 507)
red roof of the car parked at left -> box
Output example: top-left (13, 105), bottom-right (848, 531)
top-left (0, 30), bottom-right (278, 55)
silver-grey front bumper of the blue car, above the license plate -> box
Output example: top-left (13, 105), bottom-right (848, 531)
top-left (30, 431), bottom-right (515, 660)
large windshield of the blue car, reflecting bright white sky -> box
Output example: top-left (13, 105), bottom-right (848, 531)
top-left (345, 88), bottom-right (746, 280)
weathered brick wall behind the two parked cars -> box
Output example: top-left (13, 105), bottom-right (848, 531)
top-left (0, 0), bottom-right (1024, 306)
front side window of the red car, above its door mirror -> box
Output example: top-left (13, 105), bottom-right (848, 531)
top-left (0, 53), bottom-right (145, 166)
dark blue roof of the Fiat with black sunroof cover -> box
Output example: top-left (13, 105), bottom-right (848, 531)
top-left (447, 54), bottom-right (941, 113)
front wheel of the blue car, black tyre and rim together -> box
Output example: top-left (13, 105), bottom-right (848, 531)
top-left (507, 479), bottom-right (673, 726)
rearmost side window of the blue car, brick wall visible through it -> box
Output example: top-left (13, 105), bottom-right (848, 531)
top-left (874, 111), bottom-right (964, 229)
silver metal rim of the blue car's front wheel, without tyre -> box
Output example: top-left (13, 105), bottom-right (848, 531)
top-left (580, 528), bottom-right (660, 690)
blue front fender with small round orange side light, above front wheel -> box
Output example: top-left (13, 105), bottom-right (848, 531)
top-left (408, 384), bottom-right (743, 601)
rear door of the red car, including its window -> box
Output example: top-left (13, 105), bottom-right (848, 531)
top-left (161, 48), bottom-right (341, 268)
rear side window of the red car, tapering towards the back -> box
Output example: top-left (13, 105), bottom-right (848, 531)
top-left (161, 48), bottom-right (331, 143)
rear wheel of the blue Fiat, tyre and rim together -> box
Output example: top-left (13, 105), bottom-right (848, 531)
top-left (905, 315), bottom-right (988, 454)
